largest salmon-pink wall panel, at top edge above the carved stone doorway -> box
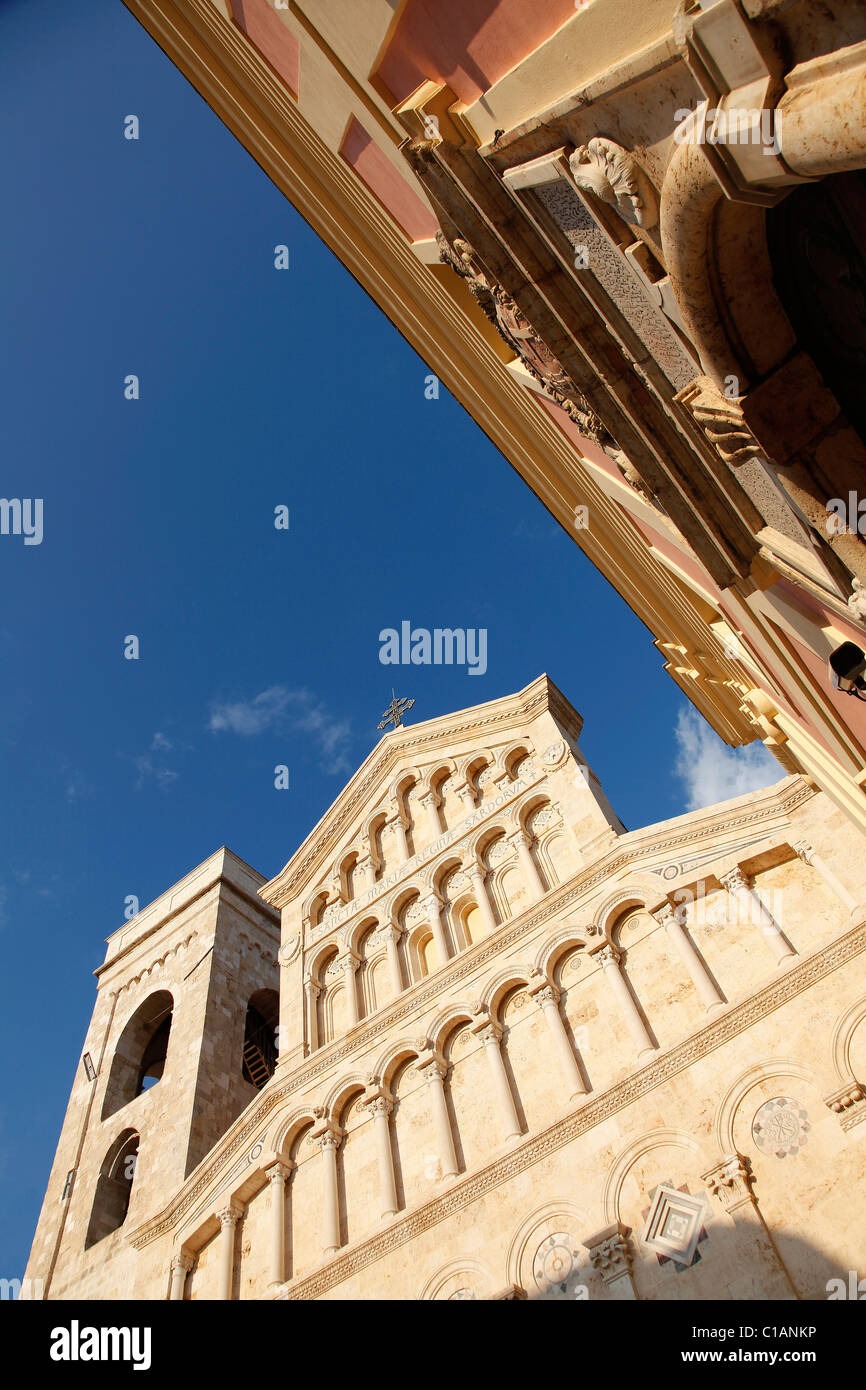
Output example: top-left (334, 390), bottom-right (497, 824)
top-left (373, 0), bottom-right (575, 106)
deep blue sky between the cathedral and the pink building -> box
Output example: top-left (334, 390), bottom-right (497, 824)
top-left (0, 0), bottom-right (783, 1277)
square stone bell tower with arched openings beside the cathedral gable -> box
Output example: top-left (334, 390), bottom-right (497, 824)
top-left (26, 849), bottom-right (279, 1298)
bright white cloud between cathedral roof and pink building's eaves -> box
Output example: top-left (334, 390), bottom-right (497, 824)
top-left (674, 709), bottom-right (785, 810)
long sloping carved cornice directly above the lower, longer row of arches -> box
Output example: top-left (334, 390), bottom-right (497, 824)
top-left (129, 780), bottom-right (811, 1248)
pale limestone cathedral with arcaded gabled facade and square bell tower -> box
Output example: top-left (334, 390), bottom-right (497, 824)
top-left (26, 677), bottom-right (866, 1301)
